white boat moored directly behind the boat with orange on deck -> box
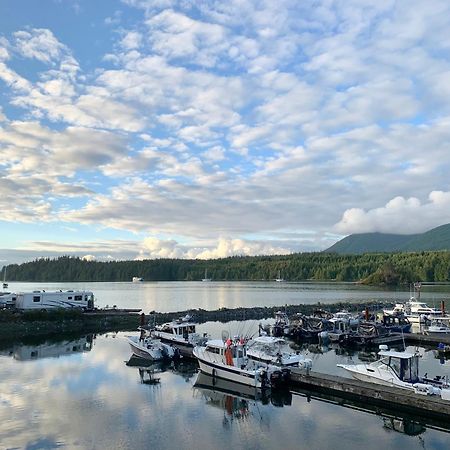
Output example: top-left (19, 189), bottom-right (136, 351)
top-left (247, 336), bottom-right (312, 369)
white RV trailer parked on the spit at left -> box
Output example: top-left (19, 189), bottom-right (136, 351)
top-left (16, 291), bottom-right (94, 311)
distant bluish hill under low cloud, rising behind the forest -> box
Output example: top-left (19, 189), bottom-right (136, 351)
top-left (325, 224), bottom-right (450, 255)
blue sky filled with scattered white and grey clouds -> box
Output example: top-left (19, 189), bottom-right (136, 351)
top-left (0, 0), bottom-right (450, 266)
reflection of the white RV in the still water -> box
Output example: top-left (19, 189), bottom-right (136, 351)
top-left (2, 334), bottom-right (93, 361)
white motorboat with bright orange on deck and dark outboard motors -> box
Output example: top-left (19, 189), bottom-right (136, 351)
top-left (193, 337), bottom-right (290, 389)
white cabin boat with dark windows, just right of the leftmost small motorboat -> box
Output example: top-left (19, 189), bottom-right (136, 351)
top-left (153, 315), bottom-right (208, 357)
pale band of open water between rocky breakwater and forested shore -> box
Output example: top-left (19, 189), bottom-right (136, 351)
top-left (5, 281), bottom-right (450, 312)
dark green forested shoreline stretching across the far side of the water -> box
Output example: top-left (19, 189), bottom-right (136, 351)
top-left (2, 251), bottom-right (450, 285)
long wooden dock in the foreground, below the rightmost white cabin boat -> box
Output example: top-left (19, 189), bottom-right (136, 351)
top-left (290, 369), bottom-right (450, 422)
